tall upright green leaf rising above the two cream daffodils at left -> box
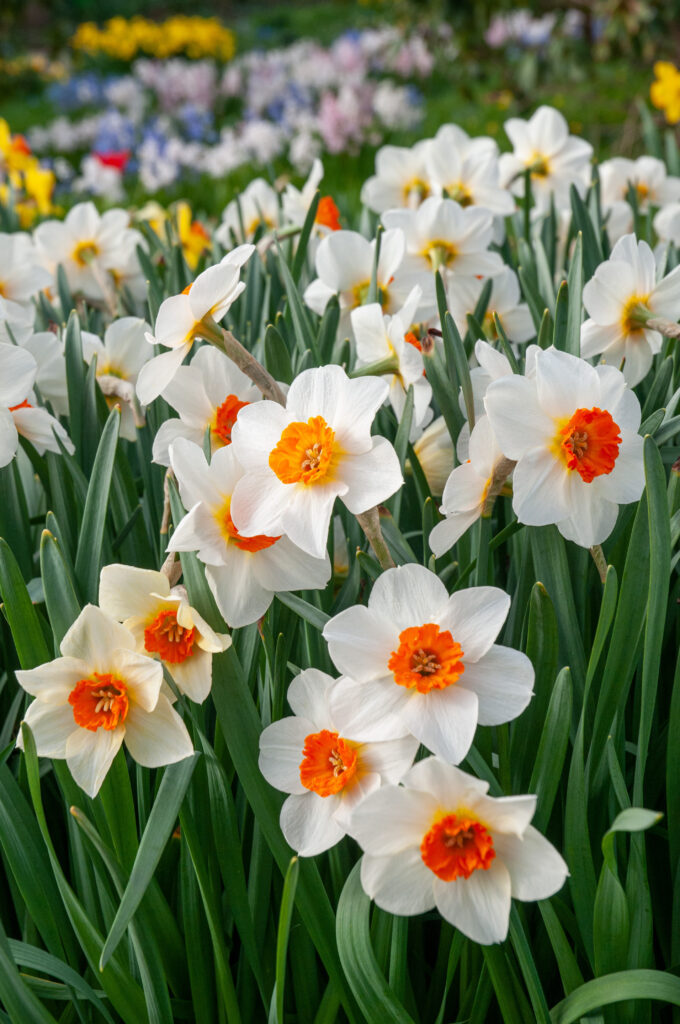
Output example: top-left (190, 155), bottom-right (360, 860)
top-left (76, 406), bottom-right (121, 603)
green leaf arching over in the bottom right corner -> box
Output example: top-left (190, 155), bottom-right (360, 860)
top-left (550, 971), bottom-right (680, 1024)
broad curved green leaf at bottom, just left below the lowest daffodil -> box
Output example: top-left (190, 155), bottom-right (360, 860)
top-left (336, 862), bottom-right (414, 1024)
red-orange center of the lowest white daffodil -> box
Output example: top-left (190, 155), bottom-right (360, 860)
top-left (420, 813), bottom-right (496, 882)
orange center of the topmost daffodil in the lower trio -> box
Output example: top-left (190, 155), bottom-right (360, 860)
top-left (387, 623), bottom-right (465, 693)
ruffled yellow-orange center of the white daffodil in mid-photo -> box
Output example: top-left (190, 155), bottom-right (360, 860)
top-left (269, 416), bottom-right (340, 483)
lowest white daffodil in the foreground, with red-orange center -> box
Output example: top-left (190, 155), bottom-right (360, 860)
top-left (350, 758), bottom-right (569, 945)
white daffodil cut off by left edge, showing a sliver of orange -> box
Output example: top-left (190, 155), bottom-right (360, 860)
top-left (0, 345), bottom-right (75, 467)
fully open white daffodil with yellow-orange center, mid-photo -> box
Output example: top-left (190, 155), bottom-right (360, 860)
top-left (231, 366), bottom-right (402, 558)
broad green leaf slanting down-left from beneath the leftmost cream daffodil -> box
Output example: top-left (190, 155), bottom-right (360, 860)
top-left (99, 754), bottom-right (199, 971)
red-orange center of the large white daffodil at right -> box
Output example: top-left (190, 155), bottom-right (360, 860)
top-left (555, 409), bottom-right (621, 483)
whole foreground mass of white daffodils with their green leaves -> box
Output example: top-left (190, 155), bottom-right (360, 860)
top-left (0, 99), bottom-right (680, 1024)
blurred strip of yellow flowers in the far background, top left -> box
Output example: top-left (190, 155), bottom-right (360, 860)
top-left (70, 14), bottom-right (236, 61)
